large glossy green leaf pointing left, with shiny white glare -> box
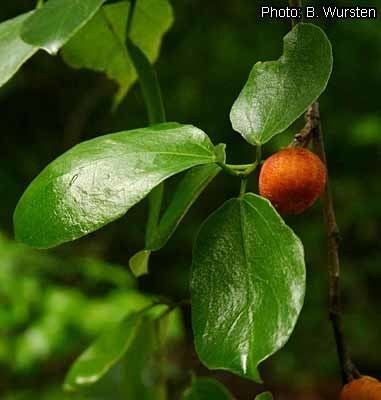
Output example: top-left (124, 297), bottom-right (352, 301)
top-left (14, 123), bottom-right (217, 248)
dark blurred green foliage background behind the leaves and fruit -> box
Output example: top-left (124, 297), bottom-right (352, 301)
top-left (0, 0), bottom-right (381, 400)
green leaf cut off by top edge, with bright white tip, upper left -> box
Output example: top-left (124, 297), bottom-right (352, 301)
top-left (21, 0), bottom-right (105, 54)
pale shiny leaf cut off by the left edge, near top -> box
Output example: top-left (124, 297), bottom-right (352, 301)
top-left (0, 11), bottom-right (38, 86)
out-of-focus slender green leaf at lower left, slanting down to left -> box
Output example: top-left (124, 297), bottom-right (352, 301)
top-left (64, 313), bottom-right (143, 390)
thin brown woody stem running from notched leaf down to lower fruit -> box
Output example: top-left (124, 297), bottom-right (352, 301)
top-left (307, 102), bottom-right (360, 383)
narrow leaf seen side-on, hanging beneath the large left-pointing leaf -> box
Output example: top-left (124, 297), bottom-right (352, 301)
top-left (147, 164), bottom-right (221, 250)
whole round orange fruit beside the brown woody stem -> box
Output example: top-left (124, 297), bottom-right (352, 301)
top-left (259, 148), bottom-right (327, 214)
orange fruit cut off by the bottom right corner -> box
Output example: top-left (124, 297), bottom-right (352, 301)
top-left (340, 376), bottom-right (381, 400)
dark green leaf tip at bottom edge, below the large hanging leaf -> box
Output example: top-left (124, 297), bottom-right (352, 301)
top-left (182, 378), bottom-right (233, 400)
